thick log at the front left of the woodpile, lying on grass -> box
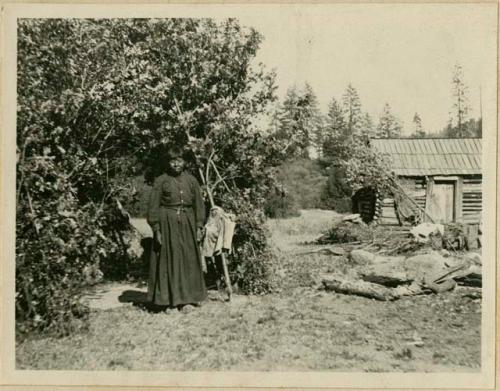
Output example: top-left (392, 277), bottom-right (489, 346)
top-left (322, 276), bottom-right (398, 301)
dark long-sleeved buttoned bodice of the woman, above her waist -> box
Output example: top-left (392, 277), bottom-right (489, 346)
top-left (148, 172), bottom-right (205, 228)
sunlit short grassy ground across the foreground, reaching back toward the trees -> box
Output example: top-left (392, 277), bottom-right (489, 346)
top-left (16, 210), bottom-right (481, 372)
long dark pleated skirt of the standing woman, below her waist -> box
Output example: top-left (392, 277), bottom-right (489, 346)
top-left (148, 208), bottom-right (207, 307)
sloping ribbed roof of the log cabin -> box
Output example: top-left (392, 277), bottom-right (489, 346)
top-left (370, 138), bottom-right (482, 176)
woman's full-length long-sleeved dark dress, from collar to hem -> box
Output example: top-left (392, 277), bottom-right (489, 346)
top-left (148, 172), bottom-right (207, 307)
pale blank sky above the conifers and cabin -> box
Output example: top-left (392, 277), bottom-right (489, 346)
top-left (238, 3), bottom-right (497, 135)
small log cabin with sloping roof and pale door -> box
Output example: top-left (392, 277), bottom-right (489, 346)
top-left (353, 138), bottom-right (482, 226)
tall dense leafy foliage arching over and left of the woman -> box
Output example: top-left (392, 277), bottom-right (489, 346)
top-left (16, 19), bottom-right (275, 332)
